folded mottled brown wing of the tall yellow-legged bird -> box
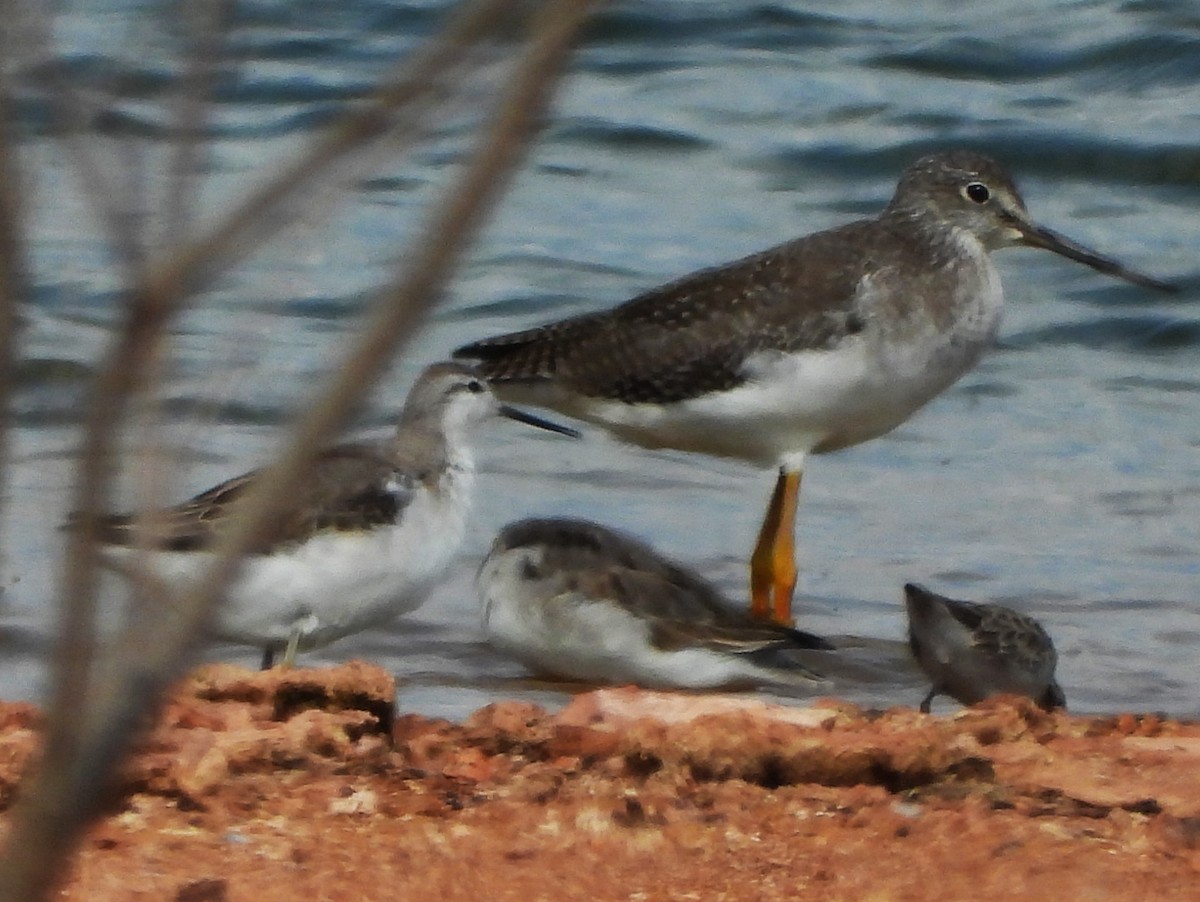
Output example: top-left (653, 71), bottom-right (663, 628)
top-left (455, 222), bottom-right (874, 403)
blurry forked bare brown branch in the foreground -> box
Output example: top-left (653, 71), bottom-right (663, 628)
top-left (0, 0), bottom-right (589, 900)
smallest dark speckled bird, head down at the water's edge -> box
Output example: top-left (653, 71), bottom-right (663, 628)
top-left (904, 583), bottom-right (1067, 714)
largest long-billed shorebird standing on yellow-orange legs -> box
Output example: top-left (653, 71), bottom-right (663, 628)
top-left (455, 151), bottom-right (1174, 624)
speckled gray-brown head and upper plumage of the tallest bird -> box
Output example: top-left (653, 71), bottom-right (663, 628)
top-left (456, 152), bottom-right (1162, 417)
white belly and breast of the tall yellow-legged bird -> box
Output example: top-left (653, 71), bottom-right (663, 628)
top-left (509, 230), bottom-right (1003, 469)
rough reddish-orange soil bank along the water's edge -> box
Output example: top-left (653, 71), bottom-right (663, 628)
top-left (0, 663), bottom-right (1200, 902)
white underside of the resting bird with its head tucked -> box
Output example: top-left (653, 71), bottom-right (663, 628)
top-left (476, 547), bottom-right (800, 688)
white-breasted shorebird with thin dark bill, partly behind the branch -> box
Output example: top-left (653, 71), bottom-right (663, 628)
top-left (87, 363), bottom-right (578, 669)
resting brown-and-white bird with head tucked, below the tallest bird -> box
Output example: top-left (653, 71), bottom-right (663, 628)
top-left (476, 519), bottom-right (833, 688)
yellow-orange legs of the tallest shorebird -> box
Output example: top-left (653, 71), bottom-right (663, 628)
top-left (750, 469), bottom-right (800, 626)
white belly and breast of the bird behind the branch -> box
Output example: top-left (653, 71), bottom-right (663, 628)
top-left (106, 455), bottom-right (474, 649)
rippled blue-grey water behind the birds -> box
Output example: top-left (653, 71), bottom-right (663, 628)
top-left (0, 0), bottom-right (1200, 717)
